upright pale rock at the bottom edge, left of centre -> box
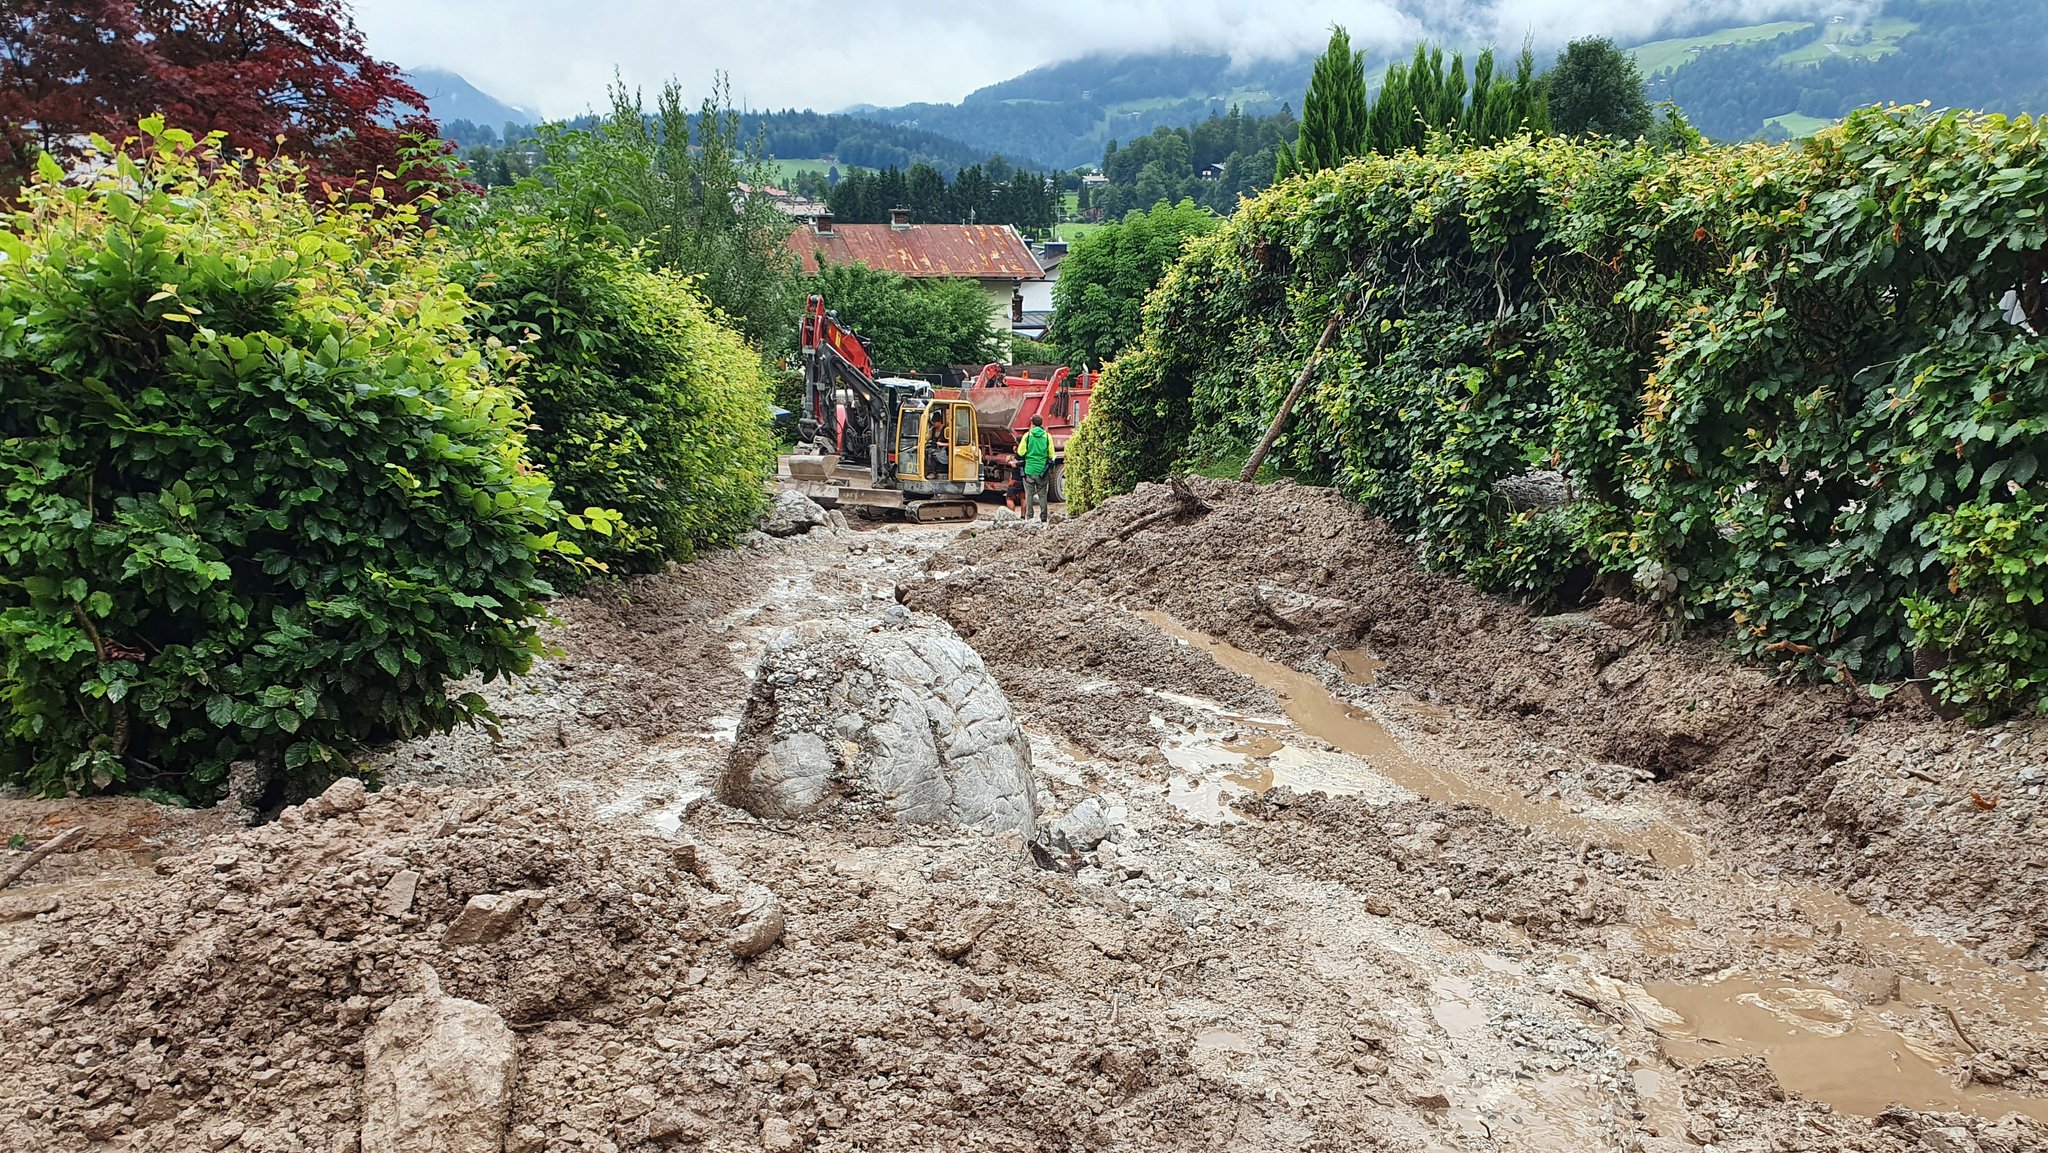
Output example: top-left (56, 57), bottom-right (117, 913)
top-left (362, 983), bottom-right (518, 1153)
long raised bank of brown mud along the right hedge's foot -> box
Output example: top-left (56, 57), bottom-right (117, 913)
top-left (903, 477), bottom-right (2048, 967)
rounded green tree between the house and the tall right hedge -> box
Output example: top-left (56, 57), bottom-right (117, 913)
top-left (1047, 201), bottom-right (1221, 365)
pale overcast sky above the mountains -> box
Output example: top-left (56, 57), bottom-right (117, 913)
top-left (354, 0), bottom-right (1858, 117)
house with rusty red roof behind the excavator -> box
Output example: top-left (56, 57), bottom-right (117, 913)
top-left (788, 209), bottom-right (1044, 348)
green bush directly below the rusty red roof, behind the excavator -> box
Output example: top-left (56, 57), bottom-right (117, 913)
top-left (813, 264), bottom-right (1004, 373)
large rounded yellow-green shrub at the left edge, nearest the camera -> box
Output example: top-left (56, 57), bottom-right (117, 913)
top-left (0, 123), bottom-right (565, 801)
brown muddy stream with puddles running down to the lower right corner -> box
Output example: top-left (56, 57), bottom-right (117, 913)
top-left (1141, 612), bottom-right (2048, 1120)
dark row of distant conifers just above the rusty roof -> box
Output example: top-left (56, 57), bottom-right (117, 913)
top-left (825, 156), bottom-right (1063, 236)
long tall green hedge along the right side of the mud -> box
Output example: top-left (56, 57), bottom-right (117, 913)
top-left (1069, 109), bottom-right (2048, 713)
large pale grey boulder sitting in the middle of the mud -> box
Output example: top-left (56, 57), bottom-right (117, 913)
top-left (717, 606), bottom-right (1038, 838)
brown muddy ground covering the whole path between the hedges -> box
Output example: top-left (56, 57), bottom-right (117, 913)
top-left (0, 481), bottom-right (2048, 1153)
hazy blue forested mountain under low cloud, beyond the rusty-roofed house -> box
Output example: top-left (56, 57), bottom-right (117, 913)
top-left (848, 51), bottom-right (1311, 168)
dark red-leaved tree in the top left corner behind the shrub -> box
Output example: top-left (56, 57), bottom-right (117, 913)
top-left (0, 0), bottom-right (436, 188)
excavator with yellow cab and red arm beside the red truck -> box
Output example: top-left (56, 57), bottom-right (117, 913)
top-left (786, 295), bottom-right (981, 524)
